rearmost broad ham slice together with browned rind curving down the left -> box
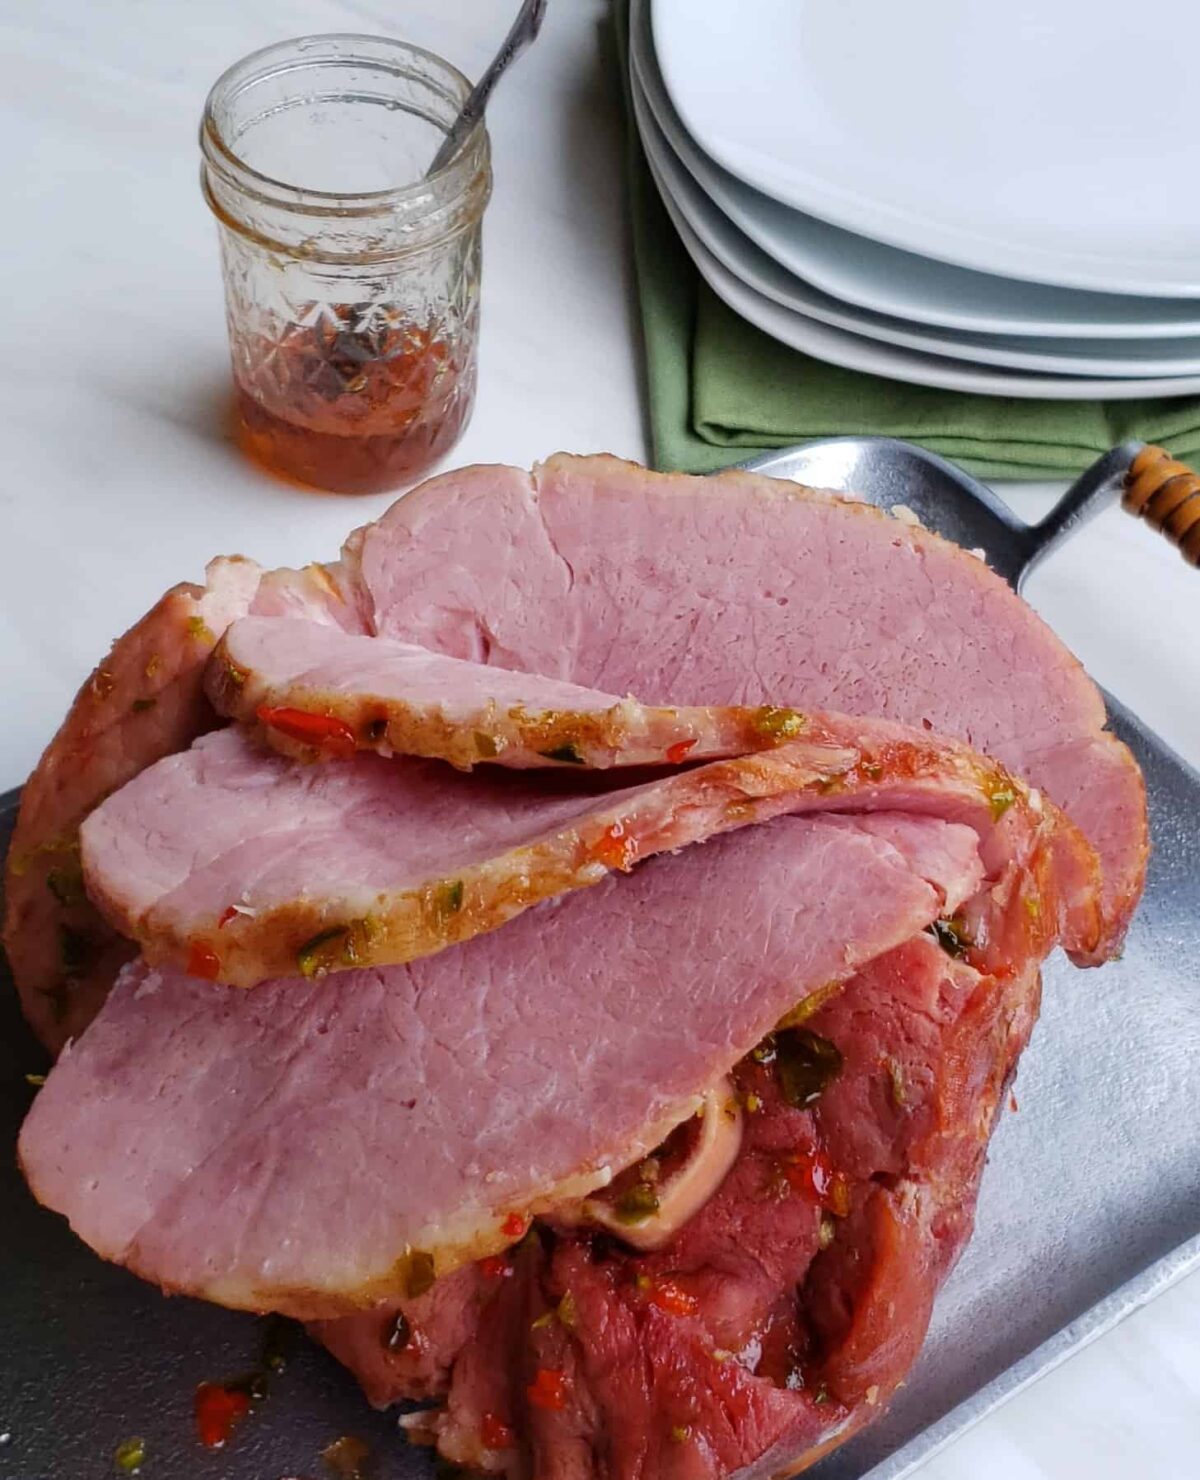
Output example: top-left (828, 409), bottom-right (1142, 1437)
top-left (4, 456), bottom-right (1147, 1049)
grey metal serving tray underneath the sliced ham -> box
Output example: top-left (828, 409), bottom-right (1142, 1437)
top-left (0, 441), bottom-right (1200, 1480)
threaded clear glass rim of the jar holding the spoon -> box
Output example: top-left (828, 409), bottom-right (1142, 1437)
top-left (200, 31), bottom-right (487, 216)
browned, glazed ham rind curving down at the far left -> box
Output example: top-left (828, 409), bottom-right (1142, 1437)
top-left (4, 559), bottom-right (262, 1052)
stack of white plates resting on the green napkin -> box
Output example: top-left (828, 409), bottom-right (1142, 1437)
top-left (630, 0), bottom-right (1200, 400)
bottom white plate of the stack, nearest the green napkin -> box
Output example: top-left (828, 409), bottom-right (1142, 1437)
top-left (647, 140), bottom-right (1200, 401)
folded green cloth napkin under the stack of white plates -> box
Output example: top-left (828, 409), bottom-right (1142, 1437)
top-left (614, 0), bottom-right (1200, 478)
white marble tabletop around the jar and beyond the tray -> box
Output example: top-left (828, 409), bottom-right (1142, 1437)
top-left (0, 0), bottom-right (1200, 1480)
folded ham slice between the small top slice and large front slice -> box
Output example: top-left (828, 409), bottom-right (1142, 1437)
top-left (81, 712), bottom-right (1096, 987)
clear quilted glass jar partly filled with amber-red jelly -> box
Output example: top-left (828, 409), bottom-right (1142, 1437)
top-left (200, 36), bottom-right (491, 493)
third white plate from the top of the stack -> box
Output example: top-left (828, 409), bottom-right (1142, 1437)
top-left (630, 77), bottom-right (1200, 380)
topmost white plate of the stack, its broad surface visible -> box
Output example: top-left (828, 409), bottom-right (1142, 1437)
top-left (653, 0), bottom-right (1200, 297)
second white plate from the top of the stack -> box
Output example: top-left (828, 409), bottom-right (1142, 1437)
top-left (630, 0), bottom-right (1200, 339)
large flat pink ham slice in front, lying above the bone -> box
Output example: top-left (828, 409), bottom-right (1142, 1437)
top-left (19, 811), bottom-right (982, 1317)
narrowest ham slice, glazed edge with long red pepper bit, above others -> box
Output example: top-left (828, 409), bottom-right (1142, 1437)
top-left (207, 617), bottom-right (789, 771)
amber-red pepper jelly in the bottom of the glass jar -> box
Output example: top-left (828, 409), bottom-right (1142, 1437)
top-left (234, 303), bottom-right (475, 493)
